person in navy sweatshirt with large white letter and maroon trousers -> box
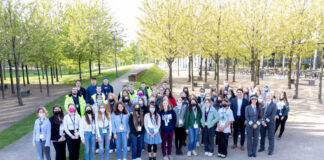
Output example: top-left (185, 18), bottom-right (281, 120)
top-left (159, 100), bottom-right (177, 160)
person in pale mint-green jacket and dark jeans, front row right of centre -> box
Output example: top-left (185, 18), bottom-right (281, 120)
top-left (201, 98), bottom-right (219, 157)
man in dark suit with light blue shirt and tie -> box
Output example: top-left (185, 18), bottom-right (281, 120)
top-left (231, 88), bottom-right (249, 151)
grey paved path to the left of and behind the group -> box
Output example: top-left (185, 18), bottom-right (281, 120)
top-left (0, 64), bottom-right (151, 160)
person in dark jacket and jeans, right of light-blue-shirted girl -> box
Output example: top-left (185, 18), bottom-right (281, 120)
top-left (129, 103), bottom-right (145, 159)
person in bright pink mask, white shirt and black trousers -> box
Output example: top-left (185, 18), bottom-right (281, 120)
top-left (63, 104), bottom-right (81, 160)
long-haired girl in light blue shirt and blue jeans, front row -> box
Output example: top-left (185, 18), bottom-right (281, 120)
top-left (112, 102), bottom-right (129, 160)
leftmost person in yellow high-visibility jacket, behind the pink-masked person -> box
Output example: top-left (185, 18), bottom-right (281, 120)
top-left (64, 87), bottom-right (86, 117)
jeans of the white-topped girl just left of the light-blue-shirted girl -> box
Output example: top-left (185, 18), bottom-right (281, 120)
top-left (99, 127), bottom-right (110, 160)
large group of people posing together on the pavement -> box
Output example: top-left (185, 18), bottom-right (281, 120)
top-left (33, 78), bottom-right (289, 160)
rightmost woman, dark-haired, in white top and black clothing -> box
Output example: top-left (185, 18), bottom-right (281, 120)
top-left (275, 92), bottom-right (289, 140)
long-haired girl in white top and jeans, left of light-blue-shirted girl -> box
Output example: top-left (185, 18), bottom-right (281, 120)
top-left (96, 104), bottom-right (112, 160)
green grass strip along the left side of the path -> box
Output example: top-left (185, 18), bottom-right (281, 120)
top-left (0, 68), bottom-right (131, 149)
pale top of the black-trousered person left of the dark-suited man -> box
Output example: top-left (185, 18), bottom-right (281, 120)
top-left (216, 107), bottom-right (234, 133)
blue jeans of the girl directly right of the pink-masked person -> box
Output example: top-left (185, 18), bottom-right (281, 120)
top-left (84, 132), bottom-right (96, 160)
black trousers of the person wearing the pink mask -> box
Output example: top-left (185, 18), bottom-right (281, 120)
top-left (66, 130), bottom-right (81, 160)
